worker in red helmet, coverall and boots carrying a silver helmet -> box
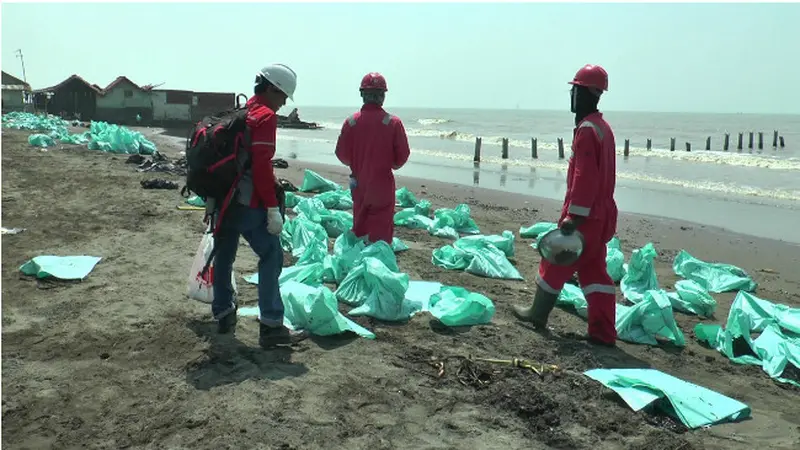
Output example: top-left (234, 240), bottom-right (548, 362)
top-left (514, 65), bottom-right (617, 345)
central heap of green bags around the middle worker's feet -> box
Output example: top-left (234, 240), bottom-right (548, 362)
top-left (240, 170), bottom-right (496, 339)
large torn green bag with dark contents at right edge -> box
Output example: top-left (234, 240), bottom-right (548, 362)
top-left (694, 291), bottom-right (800, 387)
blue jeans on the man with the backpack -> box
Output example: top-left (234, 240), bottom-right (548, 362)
top-left (211, 205), bottom-right (283, 327)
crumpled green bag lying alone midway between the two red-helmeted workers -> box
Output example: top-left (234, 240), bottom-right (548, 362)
top-left (431, 231), bottom-right (523, 280)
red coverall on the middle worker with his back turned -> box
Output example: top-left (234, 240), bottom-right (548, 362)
top-left (336, 104), bottom-right (411, 244)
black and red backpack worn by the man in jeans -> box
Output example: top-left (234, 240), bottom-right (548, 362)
top-left (183, 94), bottom-right (250, 201)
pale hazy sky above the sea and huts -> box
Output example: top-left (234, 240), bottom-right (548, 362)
top-left (2, 3), bottom-right (800, 114)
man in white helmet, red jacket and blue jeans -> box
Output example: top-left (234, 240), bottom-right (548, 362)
top-left (212, 64), bottom-right (307, 348)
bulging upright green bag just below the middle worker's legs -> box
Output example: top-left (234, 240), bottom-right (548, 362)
top-left (336, 256), bottom-right (408, 310)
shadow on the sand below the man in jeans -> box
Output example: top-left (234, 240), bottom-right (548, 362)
top-left (186, 320), bottom-right (308, 390)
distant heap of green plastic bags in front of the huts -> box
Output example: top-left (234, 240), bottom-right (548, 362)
top-left (3, 112), bottom-right (156, 155)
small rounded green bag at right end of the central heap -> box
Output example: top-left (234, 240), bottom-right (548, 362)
top-left (430, 286), bottom-right (495, 327)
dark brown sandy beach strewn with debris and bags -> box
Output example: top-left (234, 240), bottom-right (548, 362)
top-left (2, 129), bottom-right (800, 450)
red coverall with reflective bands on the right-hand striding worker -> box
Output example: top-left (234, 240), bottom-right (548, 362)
top-left (536, 112), bottom-right (617, 343)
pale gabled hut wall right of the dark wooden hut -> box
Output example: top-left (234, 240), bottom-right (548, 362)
top-left (95, 81), bottom-right (153, 124)
